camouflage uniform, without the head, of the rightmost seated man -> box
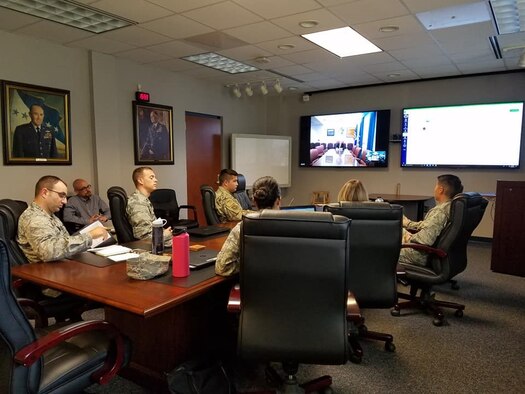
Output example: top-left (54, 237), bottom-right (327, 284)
top-left (399, 201), bottom-right (450, 267)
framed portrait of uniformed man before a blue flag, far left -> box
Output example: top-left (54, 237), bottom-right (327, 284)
top-left (1, 81), bottom-right (72, 165)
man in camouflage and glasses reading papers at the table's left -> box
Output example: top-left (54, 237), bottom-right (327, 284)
top-left (16, 175), bottom-right (109, 263)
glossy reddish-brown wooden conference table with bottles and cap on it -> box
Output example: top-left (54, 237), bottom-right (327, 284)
top-left (12, 223), bottom-right (235, 392)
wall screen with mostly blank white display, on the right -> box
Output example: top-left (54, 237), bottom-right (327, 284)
top-left (401, 102), bottom-right (523, 168)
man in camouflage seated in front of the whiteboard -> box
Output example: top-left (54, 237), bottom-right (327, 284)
top-left (215, 169), bottom-right (253, 223)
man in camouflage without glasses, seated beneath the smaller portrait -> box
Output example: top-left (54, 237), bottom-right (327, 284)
top-left (126, 167), bottom-right (171, 243)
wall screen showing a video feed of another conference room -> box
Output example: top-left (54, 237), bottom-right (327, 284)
top-left (299, 110), bottom-right (390, 168)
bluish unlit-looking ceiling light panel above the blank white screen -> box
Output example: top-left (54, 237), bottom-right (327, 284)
top-left (416, 2), bottom-right (490, 30)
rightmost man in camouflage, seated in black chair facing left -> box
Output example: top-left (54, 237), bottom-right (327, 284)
top-left (399, 174), bottom-right (463, 267)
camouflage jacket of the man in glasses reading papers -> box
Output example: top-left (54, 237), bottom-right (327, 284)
top-left (17, 202), bottom-right (92, 263)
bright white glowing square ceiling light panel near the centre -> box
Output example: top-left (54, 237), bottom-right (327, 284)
top-left (302, 27), bottom-right (381, 57)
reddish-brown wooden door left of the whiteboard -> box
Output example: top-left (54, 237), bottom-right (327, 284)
top-left (186, 112), bottom-right (222, 226)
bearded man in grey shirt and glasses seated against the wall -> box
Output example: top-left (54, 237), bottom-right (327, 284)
top-left (64, 179), bottom-right (111, 227)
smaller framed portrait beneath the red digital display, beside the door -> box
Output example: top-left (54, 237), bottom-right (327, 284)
top-left (133, 101), bottom-right (174, 165)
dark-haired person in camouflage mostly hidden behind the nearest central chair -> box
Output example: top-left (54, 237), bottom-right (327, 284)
top-left (215, 176), bottom-right (281, 276)
